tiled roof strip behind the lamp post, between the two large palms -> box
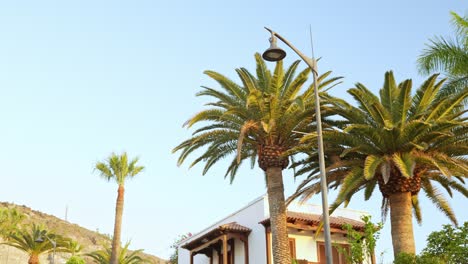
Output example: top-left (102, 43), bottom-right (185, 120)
top-left (260, 211), bottom-right (364, 229)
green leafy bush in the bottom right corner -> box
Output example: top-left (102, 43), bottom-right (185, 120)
top-left (422, 222), bottom-right (468, 264)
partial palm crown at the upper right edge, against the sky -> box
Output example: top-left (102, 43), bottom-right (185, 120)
top-left (418, 12), bottom-right (468, 93)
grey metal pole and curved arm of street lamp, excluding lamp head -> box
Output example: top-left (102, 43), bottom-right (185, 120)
top-left (265, 27), bottom-right (333, 264)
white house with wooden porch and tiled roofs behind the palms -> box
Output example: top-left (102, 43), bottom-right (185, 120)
top-left (179, 195), bottom-right (372, 264)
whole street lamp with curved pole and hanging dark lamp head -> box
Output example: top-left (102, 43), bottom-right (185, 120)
top-left (262, 27), bottom-right (333, 264)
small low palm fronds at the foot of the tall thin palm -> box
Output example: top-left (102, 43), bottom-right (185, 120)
top-left (86, 242), bottom-right (150, 264)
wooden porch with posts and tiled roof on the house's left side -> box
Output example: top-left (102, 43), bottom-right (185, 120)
top-left (182, 222), bottom-right (252, 264)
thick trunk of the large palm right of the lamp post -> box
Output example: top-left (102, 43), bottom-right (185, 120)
top-left (389, 192), bottom-right (415, 257)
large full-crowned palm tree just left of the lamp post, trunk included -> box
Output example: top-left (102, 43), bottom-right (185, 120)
top-left (173, 53), bottom-right (339, 264)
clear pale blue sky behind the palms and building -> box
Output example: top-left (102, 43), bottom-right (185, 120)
top-left (0, 0), bottom-right (468, 260)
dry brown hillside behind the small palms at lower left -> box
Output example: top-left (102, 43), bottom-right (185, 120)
top-left (0, 202), bottom-right (166, 264)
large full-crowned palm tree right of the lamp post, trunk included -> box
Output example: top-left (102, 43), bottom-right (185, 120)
top-left (290, 72), bottom-right (468, 256)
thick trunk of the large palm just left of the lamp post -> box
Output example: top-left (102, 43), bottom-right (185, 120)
top-left (266, 167), bottom-right (291, 264)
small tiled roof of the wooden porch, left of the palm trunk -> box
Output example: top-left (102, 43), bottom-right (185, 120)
top-left (182, 222), bottom-right (252, 250)
